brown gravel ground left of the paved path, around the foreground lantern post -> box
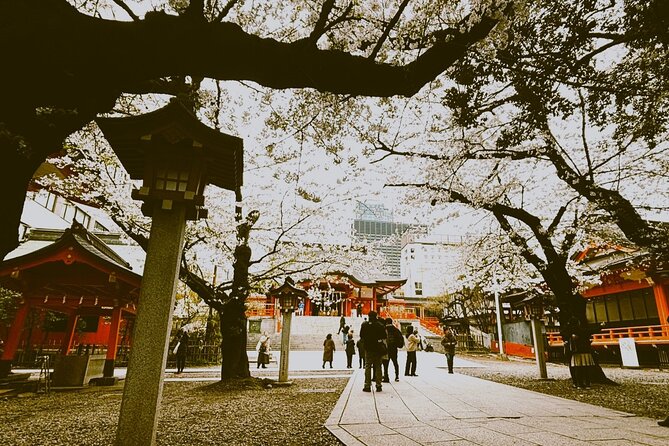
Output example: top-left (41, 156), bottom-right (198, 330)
top-left (0, 378), bottom-right (347, 446)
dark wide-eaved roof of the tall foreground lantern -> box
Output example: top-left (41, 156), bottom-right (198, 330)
top-left (95, 99), bottom-right (244, 191)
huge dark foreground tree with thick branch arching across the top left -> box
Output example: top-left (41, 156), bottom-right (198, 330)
top-left (0, 0), bottom-right (506, 256)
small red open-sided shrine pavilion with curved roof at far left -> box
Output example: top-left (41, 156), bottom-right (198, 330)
top-left (0, 222), bottom-right (142, 377)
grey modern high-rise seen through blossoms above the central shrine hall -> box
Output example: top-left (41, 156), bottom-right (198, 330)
top-left (353, 202), bottom-right (420, 277)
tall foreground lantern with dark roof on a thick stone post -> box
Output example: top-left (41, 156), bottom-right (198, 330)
top-left (96, 101), bottom-right (243, 446)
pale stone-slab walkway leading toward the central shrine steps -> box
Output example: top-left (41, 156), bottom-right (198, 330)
top-left (326, 353), bottom-right (669, 446)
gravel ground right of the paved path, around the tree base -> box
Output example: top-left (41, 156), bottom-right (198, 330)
top-left (457, 355), bottom-right (669, 419)
